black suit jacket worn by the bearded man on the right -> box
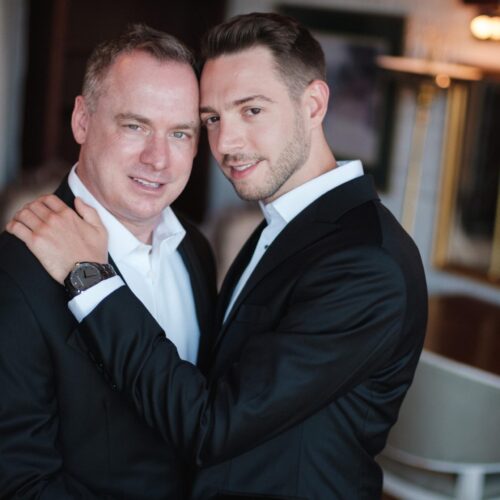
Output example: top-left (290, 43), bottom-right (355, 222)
top-left (69, 176), bottom-right (427, 500)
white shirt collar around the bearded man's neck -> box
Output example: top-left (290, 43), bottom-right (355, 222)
top-left (259, 160), bottom-right (363, 225)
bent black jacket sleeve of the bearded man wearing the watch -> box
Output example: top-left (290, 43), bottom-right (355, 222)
top-left (77, 248), bottom-right (406, 466)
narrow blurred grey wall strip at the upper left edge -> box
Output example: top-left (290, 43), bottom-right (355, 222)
top-left (0, 0), bottom-right (26, 188)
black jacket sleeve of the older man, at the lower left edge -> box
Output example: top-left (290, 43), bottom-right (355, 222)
top-left (0, 271), bottom-right (102, 500)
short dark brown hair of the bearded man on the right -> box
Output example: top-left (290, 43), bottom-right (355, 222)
top-left (202, 12), bottom-right (326, 98)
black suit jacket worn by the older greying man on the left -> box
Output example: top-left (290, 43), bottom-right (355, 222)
top-left (0, 181), bottom-right (215, 500)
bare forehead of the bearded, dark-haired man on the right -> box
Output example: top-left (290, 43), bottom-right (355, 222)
top-left (200, 47), bottom-right (288, 106)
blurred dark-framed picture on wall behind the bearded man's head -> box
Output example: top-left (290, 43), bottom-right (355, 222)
top-left (279, 5), bottom-right (405, 191)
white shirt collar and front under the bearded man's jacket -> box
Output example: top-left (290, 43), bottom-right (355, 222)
top-left (224, 160), bottom-right (363, 321)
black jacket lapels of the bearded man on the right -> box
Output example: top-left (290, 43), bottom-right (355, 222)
top-left (216, 175), bottom-right (378, 345)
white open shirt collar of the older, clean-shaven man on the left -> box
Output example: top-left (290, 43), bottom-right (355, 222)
top-left (68, 165), bottom-right (186, 261)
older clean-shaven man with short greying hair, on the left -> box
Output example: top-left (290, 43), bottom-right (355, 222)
top-left (0, 25), bottom-right (215, 500)
